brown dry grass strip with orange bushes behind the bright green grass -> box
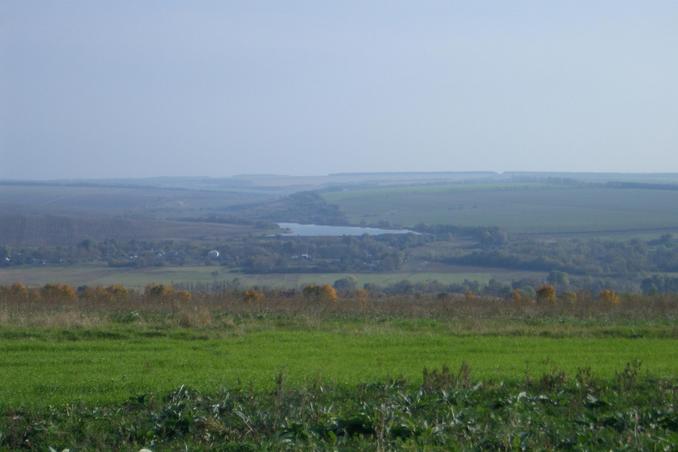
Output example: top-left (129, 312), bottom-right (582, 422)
top-left (0, 285), bottom-right (678, 329)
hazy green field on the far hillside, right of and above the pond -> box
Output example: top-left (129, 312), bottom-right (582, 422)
top-left (323, 184), bottom-right (678, 233)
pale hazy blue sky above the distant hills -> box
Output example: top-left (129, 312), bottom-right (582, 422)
top-left (0, 0), bottom-right (678, 179)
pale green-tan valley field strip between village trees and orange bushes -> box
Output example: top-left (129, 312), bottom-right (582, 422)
top-left (0, 266), bottom-right (543, 288)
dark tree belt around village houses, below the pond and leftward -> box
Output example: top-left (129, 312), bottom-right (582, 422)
top-left (0, 234), bottom-right (426, 273)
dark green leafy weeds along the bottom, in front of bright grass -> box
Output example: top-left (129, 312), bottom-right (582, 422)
top-left (0, 365), bottom-right (678, 450)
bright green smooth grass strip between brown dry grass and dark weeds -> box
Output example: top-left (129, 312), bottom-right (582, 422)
top-left (0, 321), bottom-right (678, 407)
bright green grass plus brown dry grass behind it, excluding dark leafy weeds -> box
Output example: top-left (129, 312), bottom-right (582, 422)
top-left (0, 286), bottom-right (678, 406)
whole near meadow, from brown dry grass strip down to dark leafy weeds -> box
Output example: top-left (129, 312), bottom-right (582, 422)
top-left (0, 286), bottom-right (678, 451)
